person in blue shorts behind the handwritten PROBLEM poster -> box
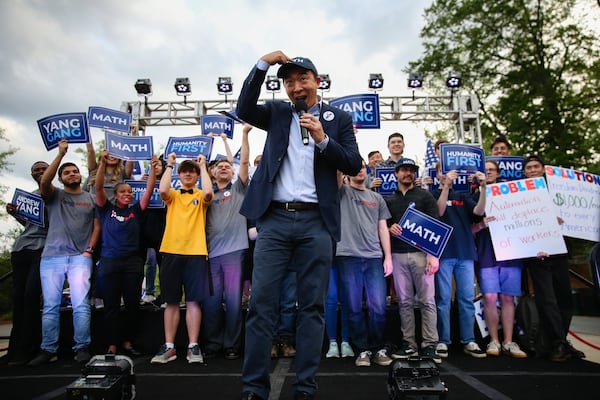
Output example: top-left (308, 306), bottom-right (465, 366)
top-left (471, 161), bottom-right (527, 358)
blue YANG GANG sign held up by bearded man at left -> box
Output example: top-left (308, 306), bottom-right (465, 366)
top-left (37, 113), bottom-right (90, 150)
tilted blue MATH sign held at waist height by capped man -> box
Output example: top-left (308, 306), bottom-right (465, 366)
top-left (396, 207), bottom-right (453, 257)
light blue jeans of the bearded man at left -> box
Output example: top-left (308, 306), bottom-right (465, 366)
top-left (40, 254), bottom-right (92, 353)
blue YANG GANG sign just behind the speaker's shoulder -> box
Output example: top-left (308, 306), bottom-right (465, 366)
top-left (329, 93), bottom-right (381, 129)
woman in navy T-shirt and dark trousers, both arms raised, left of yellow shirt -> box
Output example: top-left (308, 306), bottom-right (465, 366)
top-left (96, 150), bottom-right (160, 356)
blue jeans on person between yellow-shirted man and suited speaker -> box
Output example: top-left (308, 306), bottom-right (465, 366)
top-left (202, 250), bottom-right (244, 352)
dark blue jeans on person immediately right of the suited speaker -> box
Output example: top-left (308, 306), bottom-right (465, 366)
top-left (335, 257), bottom-right (386, 351)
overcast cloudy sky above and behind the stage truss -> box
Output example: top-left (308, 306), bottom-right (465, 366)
top-left (0, 0), bottom-right (431, 234)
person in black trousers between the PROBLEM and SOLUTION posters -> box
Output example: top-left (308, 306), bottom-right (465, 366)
top-left (523, 155), bottom-right (585, 362)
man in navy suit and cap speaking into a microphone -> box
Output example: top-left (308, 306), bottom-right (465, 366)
top-left (236, 51), bottom-right (362, 399)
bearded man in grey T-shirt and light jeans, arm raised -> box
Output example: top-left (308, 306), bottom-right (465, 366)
top-left (27, 139), bottom-right (100, 366)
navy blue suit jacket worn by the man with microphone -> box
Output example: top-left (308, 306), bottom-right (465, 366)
top-left (236, 67), bottom-right (362, 242)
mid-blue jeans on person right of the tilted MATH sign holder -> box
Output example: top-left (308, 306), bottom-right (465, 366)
top-left (435, 258), bottom-right (475, 344)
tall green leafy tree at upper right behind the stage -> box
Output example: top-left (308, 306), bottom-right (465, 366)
top-left (407, 0), bottom-right (600, 173)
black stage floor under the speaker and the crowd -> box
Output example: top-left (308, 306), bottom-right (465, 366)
top-left (0, 309), bottom-right (600, 400)
